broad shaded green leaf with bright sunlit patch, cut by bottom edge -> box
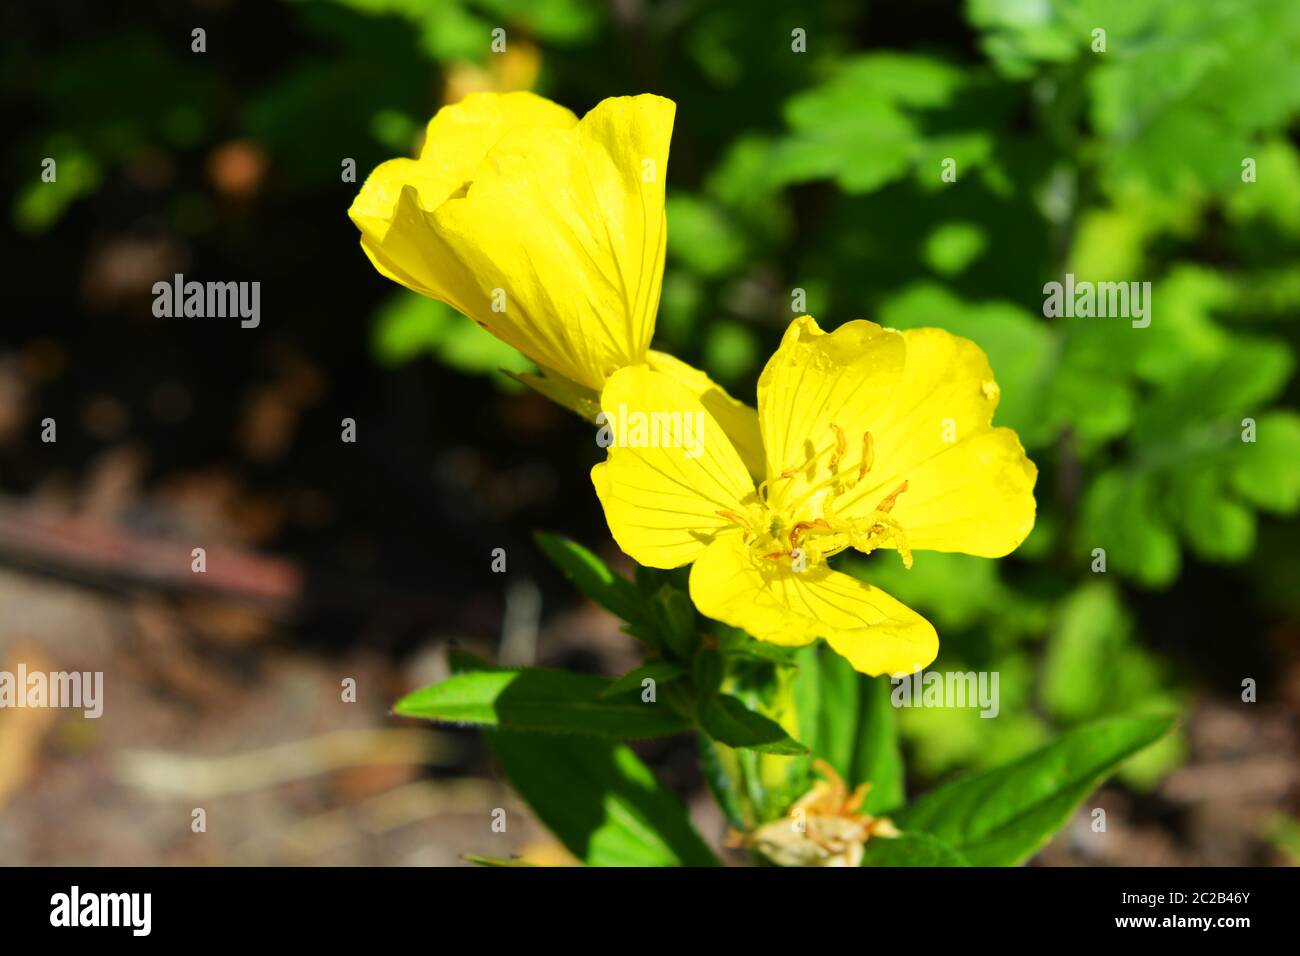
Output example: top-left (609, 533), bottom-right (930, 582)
top-left (488, 731), bottom-right (718, 866)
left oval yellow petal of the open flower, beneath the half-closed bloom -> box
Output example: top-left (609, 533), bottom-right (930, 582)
top-left (592, 365), bottom-right (754, 567)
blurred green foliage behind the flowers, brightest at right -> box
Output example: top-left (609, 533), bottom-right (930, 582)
top-left (3, 0), bottom-right (1300, 801)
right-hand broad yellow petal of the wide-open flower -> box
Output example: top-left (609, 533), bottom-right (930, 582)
top-left (836, 329), bottom-right (1037, 558)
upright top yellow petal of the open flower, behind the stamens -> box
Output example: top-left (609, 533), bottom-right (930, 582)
top-left (758, 316), bottom-right (905, 510)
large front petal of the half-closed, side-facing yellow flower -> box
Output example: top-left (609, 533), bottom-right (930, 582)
top-left (367, 89), bottom-right (675, 390)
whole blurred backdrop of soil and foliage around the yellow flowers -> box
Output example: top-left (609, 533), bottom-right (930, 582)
top-left (0, 0), bottom-right (1300, 865)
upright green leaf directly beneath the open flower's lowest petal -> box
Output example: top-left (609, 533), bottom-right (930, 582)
top-left (794, 644), bottom-right (904, 813)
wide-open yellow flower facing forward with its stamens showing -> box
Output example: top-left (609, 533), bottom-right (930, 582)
top-left (592, 316), bottom-right (1037, 675)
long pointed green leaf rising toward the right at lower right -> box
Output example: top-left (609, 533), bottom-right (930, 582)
top-left (892, 715), bottom-right (1175, 866)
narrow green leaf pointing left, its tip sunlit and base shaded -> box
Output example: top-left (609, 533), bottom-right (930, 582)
top-left (393, 667), bottom-right (689, 740)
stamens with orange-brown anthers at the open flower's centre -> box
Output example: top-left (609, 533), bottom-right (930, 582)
top-left (718, 423), bottom-right (911, 571)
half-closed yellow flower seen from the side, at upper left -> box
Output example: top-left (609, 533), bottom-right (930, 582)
top-left (348, 92), bottom-right (761, 470)
